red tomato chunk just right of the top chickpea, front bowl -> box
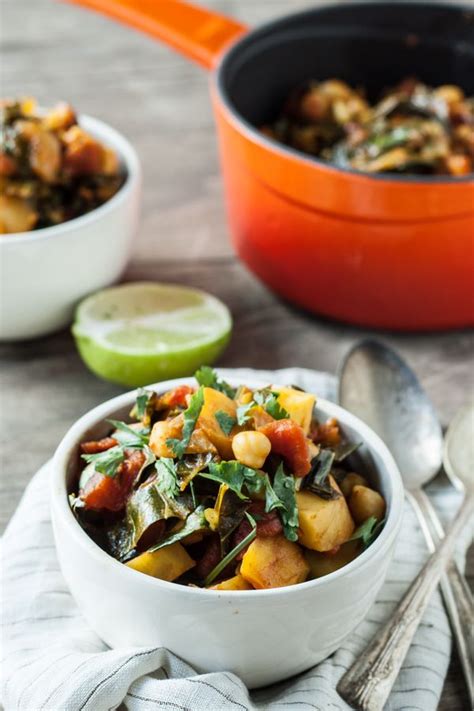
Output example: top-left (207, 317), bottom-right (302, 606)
top-left (259, 420), bottom-right (311, 476)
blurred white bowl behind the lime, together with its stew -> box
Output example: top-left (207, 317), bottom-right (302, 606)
top-left (0, 103), bottom-right (141, 341)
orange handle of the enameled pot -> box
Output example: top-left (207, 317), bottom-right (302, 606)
top-left (66, 0), bottom-right (247, 69)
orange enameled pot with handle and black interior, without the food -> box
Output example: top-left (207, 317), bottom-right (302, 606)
top-left (67, 0), bottom-right (474, 329)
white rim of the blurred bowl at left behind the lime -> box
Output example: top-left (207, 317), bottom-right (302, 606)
top-left (0, 114), bottom-right (141, 249)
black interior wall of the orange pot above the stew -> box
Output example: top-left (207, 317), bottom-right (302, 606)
top-left (218, 2), bottom-right (474, 126)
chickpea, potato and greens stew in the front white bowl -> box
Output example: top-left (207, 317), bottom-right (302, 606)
top-left (71, 366), bottom-right (386, 590)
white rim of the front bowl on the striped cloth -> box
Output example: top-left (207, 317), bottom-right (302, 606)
top-left (50, 377), bottom-right (404, 603)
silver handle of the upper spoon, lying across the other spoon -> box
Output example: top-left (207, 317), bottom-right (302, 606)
top-left (337, 495), bottom-right (473, 711)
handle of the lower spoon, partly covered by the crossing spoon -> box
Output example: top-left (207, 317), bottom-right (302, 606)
top-left (407, 488), bottom-right (474, 708)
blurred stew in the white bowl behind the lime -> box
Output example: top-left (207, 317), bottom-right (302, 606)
top-left (0, 99), bottom-right (125, 234)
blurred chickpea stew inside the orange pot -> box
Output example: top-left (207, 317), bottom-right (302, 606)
top-left (262, 79), bottom-right (474, 176)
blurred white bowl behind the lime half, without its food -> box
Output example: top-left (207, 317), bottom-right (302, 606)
top-left (0, 116), bottom-right (141, 341)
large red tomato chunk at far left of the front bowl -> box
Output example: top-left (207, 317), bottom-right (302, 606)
top-left (81, 449), bottom-right (145, 511)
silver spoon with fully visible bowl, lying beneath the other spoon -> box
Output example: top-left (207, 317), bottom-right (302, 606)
top-left (339, 340), bottom-right (472, 700)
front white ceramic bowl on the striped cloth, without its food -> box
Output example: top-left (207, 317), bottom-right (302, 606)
top-left (51, 379), bottom-right (403, 688)
